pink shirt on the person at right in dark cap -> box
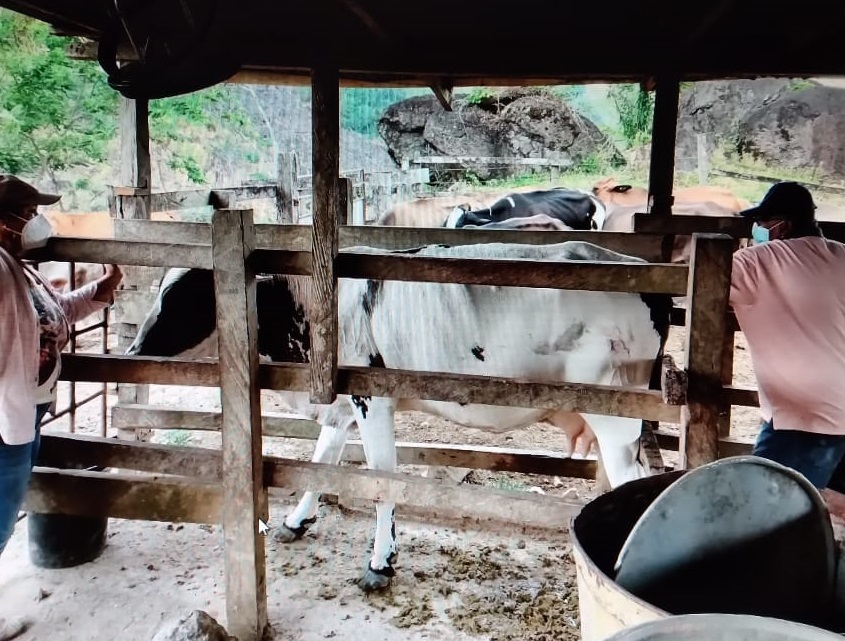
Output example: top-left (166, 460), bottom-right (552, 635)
top-left (730, 236), bottom-right (845, 434)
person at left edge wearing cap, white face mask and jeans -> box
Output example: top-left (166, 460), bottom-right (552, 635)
top-left (0, 175), bottom-right (123, 641)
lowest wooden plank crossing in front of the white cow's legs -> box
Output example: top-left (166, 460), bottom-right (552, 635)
top-left (265, 457), bottom-right (583, 530)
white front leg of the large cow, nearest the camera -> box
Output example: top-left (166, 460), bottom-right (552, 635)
top-left (350, 396), bottom-right (397, 592)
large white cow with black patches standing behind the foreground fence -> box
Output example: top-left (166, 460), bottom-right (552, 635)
top-left (126, 241), bottom-right (671, 591)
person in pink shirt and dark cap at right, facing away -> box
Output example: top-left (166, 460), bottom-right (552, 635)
top-left (730, 182), bottom-right (845, 489)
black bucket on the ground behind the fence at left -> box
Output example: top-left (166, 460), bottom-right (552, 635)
top-left (27, 466), bottom-right (109, 570)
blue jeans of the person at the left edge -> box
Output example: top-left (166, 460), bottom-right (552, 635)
top-left (0, 403), bottom-right (50, 554)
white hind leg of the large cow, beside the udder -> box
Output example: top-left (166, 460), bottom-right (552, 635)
top-left (582, 414), bottom-right (648, 488)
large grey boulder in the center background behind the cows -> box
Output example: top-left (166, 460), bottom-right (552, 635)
top-left (378, 89), bottom-right (624, 181)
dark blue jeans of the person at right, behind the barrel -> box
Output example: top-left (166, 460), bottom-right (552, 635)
top-left (751, 421), bottom-right (845, 489)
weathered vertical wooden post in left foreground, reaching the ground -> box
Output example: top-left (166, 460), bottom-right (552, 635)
top-left (211, 210), bottom-right (268, 641)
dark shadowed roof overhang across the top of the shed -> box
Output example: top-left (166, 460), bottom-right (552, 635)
top-left (0, 0), bottom-right (845, 94)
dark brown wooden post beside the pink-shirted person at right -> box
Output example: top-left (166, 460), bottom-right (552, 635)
top-left (679, 234), bottom-right (733, 469)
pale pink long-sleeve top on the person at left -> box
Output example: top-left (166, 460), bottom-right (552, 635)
top-left (0, 248), bottom-right (108, 445)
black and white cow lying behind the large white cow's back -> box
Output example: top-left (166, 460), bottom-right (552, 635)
top-left (444, 187), bottom-right (604, 231)
